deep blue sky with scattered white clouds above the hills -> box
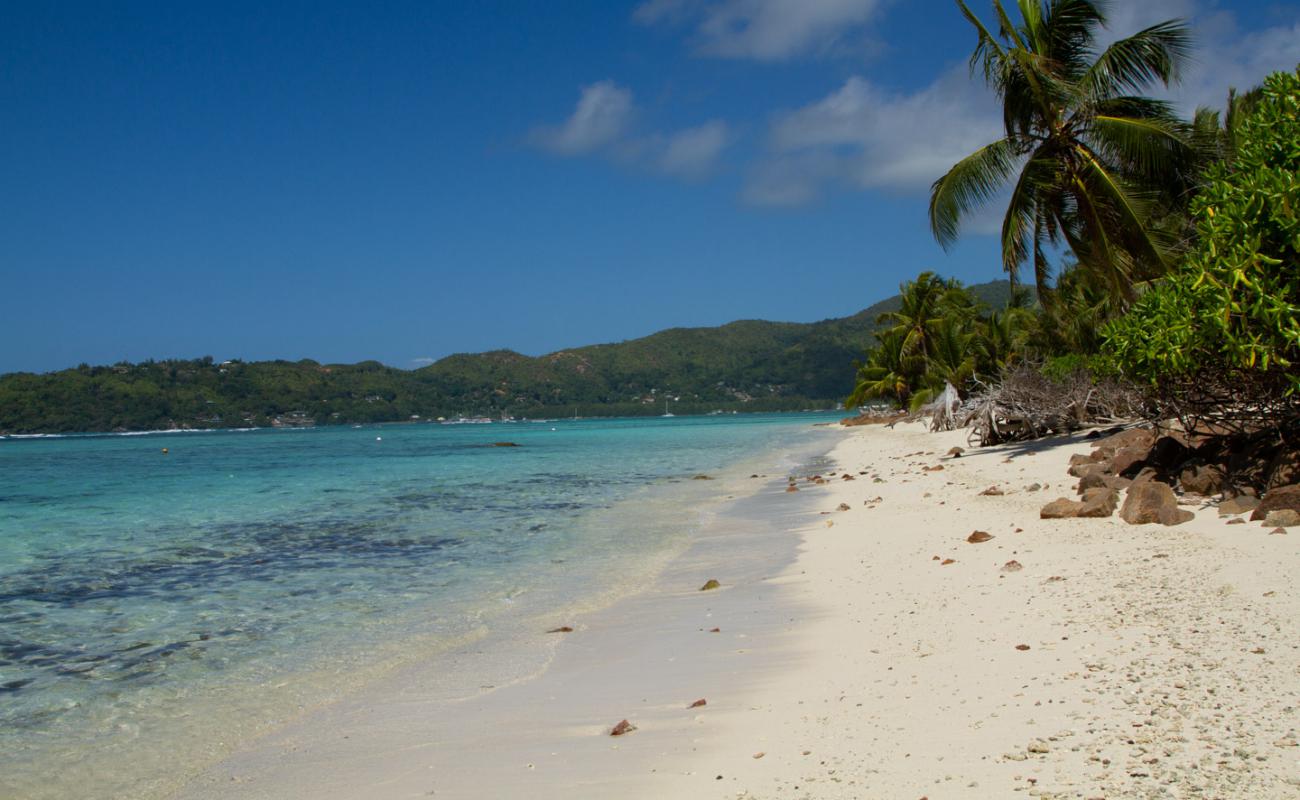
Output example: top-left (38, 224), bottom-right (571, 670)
top-left (0, 0), bottom-right (1300, 372)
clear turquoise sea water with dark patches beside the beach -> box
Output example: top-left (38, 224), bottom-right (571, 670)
top-left (0, 415), bottom-right (835, 797)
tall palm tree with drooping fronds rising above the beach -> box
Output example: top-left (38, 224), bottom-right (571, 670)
top-left (930, 0), bottom-right (1192, 303)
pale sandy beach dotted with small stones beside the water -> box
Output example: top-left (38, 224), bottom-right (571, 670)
top-left (179, 425), bottom-right (1300, 800)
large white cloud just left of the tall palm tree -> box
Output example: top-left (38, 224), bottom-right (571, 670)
top-left (742, 66), bottom-right (1001, 206)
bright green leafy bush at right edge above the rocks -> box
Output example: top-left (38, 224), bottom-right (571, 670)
top-left (1105, 67), bottom-right (1300, 403)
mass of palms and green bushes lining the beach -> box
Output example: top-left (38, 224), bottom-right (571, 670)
top-left (848, 0), bottom-right (1300, 434)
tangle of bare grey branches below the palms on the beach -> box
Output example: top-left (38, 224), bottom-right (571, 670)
top-left (951, 364), bottom-right (1144, 446)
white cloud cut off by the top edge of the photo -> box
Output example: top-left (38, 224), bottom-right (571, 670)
top-left (633, 0), bottom-right (883, 61)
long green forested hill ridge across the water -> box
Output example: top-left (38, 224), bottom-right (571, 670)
top-left (0, 281), bottom-right (1010, 433)
